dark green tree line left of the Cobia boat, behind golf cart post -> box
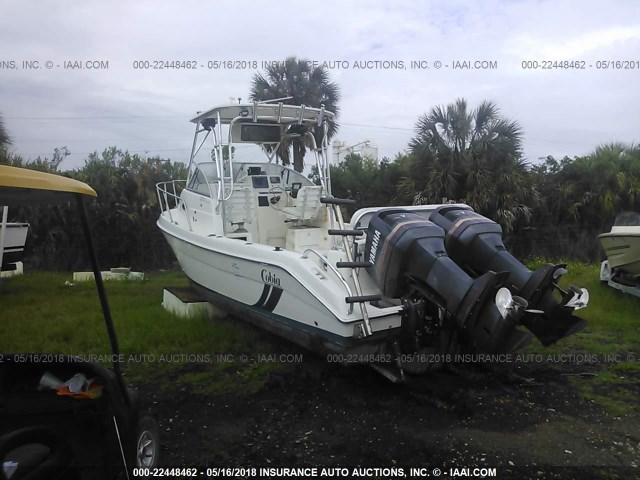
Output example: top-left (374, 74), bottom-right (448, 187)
top-left (0, 147), bottom-right (187, 271)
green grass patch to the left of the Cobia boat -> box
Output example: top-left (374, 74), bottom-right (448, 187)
top-left (0, 272), bottom-right (290, 393)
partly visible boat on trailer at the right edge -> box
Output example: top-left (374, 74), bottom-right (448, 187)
top-left (598, 212), bottom-right (640, 296)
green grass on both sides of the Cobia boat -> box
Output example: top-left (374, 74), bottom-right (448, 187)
top-left (0, 260), bottom-right (640, 402)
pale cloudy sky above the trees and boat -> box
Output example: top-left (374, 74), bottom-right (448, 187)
top-left (0, 0), bottom-right (640, 170)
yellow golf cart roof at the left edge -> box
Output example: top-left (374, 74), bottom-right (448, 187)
top-left (0, 165), bottom-right (97, 205)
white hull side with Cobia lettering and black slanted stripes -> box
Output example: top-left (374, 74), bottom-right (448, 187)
top-left (158, 217), bottom-right (402, 352)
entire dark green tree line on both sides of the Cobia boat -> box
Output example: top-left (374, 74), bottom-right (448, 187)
top-left (0, 128), bottom-right (640, 271)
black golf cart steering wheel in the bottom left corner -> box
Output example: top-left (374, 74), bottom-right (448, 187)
top-left (0, 427), bottom-right (75, 480)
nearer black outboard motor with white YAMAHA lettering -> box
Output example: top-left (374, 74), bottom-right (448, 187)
top-left (364, 209), bottom-right (531, 353)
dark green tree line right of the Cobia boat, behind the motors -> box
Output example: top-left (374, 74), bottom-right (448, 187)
top-left (331, 143), bottom-right (640, 262)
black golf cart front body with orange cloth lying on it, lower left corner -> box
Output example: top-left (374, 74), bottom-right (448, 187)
top-left (0, 354), bottom-right (138, 480)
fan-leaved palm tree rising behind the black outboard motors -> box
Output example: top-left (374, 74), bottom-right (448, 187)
top-left (405, 99), bottom-right (536, 231)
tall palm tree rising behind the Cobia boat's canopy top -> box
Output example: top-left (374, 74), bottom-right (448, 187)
top-left (249, 57), bottom-right (340, 172)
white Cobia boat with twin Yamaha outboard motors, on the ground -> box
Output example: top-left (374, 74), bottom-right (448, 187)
top-left (157, 100), bottom-right (588, 380)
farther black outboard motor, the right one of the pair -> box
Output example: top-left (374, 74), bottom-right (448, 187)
top-left (430, 206), bottom-right (589, 345)
